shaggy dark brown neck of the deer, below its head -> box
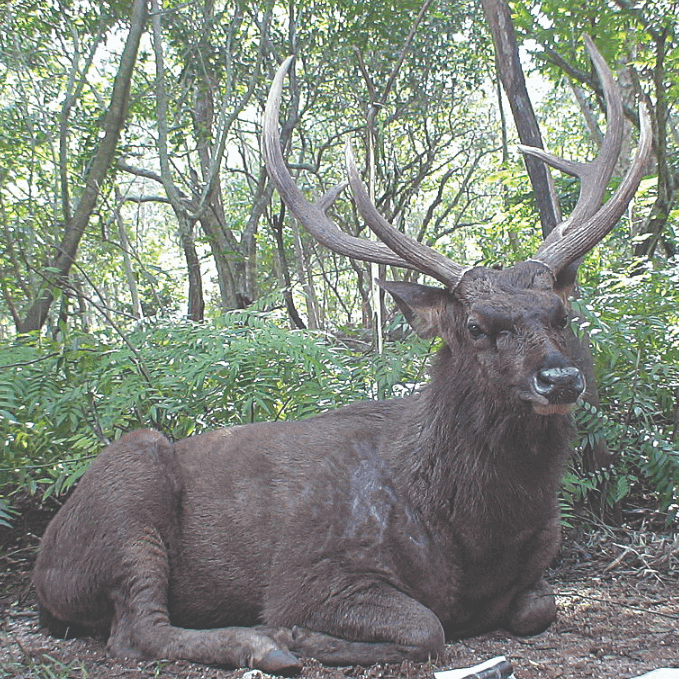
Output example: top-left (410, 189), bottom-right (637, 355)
top-left (399, 348), bottom-right (571, 514)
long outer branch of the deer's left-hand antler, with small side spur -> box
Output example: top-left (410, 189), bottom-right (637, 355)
top-left (262, 57), bottom-right (422, 269)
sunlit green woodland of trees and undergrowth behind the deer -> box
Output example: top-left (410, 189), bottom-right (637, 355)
top-left (0, 0), bottom-right (679, 526)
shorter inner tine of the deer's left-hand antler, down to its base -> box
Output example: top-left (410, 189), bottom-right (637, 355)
top-left (345, 141), bottom-right (466, 288)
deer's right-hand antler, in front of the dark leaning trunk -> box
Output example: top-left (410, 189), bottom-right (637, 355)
top-left (520, 35), bottom-right (652, 275)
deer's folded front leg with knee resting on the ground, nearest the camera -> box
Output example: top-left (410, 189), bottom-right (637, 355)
top-left (265, 583), bottom-right (445, 665)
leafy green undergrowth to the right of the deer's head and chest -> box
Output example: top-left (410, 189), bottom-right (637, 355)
top-left (565, 268), bottom-right (679, 518)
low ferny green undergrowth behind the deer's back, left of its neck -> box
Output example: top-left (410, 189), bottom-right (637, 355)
top-left (0, 312), bottom-right (427, 510)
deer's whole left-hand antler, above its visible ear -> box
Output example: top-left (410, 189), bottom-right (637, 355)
top-left (262, 57), bottom-right (464, 287)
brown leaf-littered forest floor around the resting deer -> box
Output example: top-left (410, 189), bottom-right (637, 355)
top-left (0, 500), bottom-right (679, 679)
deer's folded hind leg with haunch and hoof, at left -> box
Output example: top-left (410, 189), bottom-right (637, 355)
top-left (33, 431), bottom-right (301, 674)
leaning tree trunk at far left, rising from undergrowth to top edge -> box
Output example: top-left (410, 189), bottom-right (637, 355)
top-left (17, 0), bottom-right (147, 333)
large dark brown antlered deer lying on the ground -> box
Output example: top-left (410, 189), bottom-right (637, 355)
top-left (33, 38), bottom-right (651, 674)
